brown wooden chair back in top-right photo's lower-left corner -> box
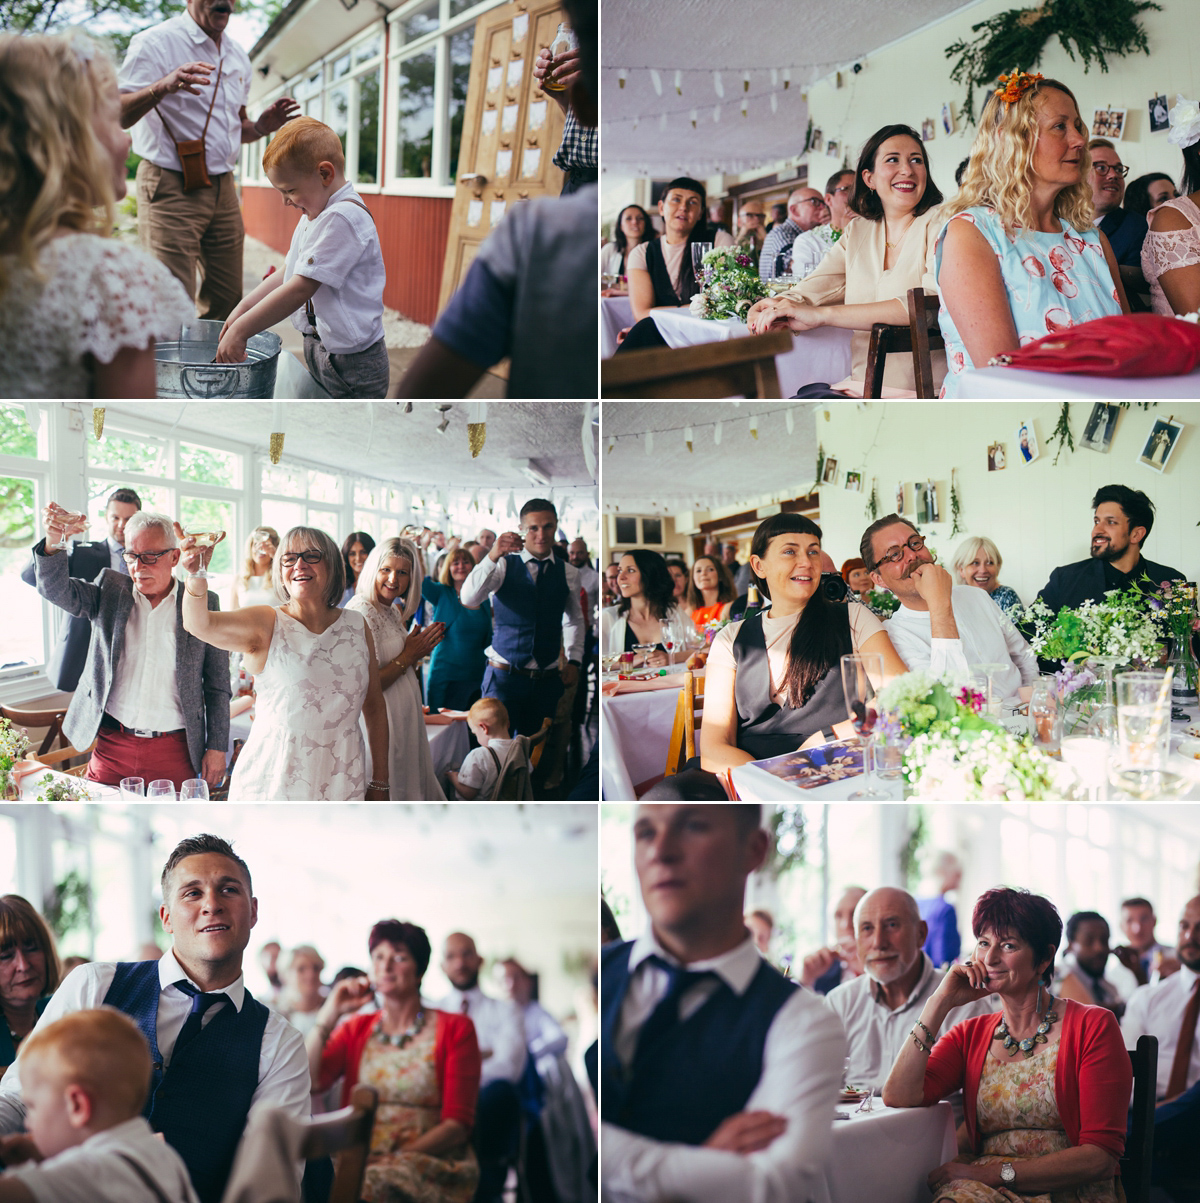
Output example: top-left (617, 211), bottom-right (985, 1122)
top-left (600, 330), bottom-right (794, 399)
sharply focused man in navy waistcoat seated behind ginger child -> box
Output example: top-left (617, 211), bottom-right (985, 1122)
top-left (0, 835), bottom-right (311, 1203)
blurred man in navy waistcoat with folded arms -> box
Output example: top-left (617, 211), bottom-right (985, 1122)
top-left (600, 804), bottom-right (845, 1203)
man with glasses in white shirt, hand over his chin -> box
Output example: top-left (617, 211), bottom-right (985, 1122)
top-left (860, 514), bottom-right (1038, 698)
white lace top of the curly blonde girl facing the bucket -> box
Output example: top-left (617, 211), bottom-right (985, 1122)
top-left (0, 233), bottom-right (196, 398)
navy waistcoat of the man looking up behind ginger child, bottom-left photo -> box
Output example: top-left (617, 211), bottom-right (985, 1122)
top-left (103, 961), bottom-right (271, 1203)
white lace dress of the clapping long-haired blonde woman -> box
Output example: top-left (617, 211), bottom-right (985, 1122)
top-left (345, 595), bottom-right (446, 802)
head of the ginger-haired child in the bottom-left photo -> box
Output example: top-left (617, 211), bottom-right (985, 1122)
top-left (20, 1007), bottom-right (152, 1157)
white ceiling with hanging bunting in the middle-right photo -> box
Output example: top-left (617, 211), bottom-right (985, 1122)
top-left (600, 401), bottom-right (816, 514)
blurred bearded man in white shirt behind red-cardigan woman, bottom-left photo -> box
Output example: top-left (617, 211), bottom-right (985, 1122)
top-left (434, 933), bottom-right (528, 1203)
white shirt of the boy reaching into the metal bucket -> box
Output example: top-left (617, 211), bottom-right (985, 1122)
top-left (284, 183), bottom-right (387, 355)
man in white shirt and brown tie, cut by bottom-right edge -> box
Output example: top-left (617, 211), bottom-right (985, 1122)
top-left (1121, 894), bottom-right (1200, 1199)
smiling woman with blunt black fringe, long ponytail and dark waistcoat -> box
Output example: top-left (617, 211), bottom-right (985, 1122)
top-left (644, 514), bottom-right (907, 801)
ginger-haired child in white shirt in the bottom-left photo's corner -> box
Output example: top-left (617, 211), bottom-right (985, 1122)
top-left (0, 1007), bottom-right (198, 1203)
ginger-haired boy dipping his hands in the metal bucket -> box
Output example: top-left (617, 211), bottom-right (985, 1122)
top-left (216, 117), bottom-right (388, 397)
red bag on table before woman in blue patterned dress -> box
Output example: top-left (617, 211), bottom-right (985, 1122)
top-left (987, 313), bottom-right (1200, 377)
